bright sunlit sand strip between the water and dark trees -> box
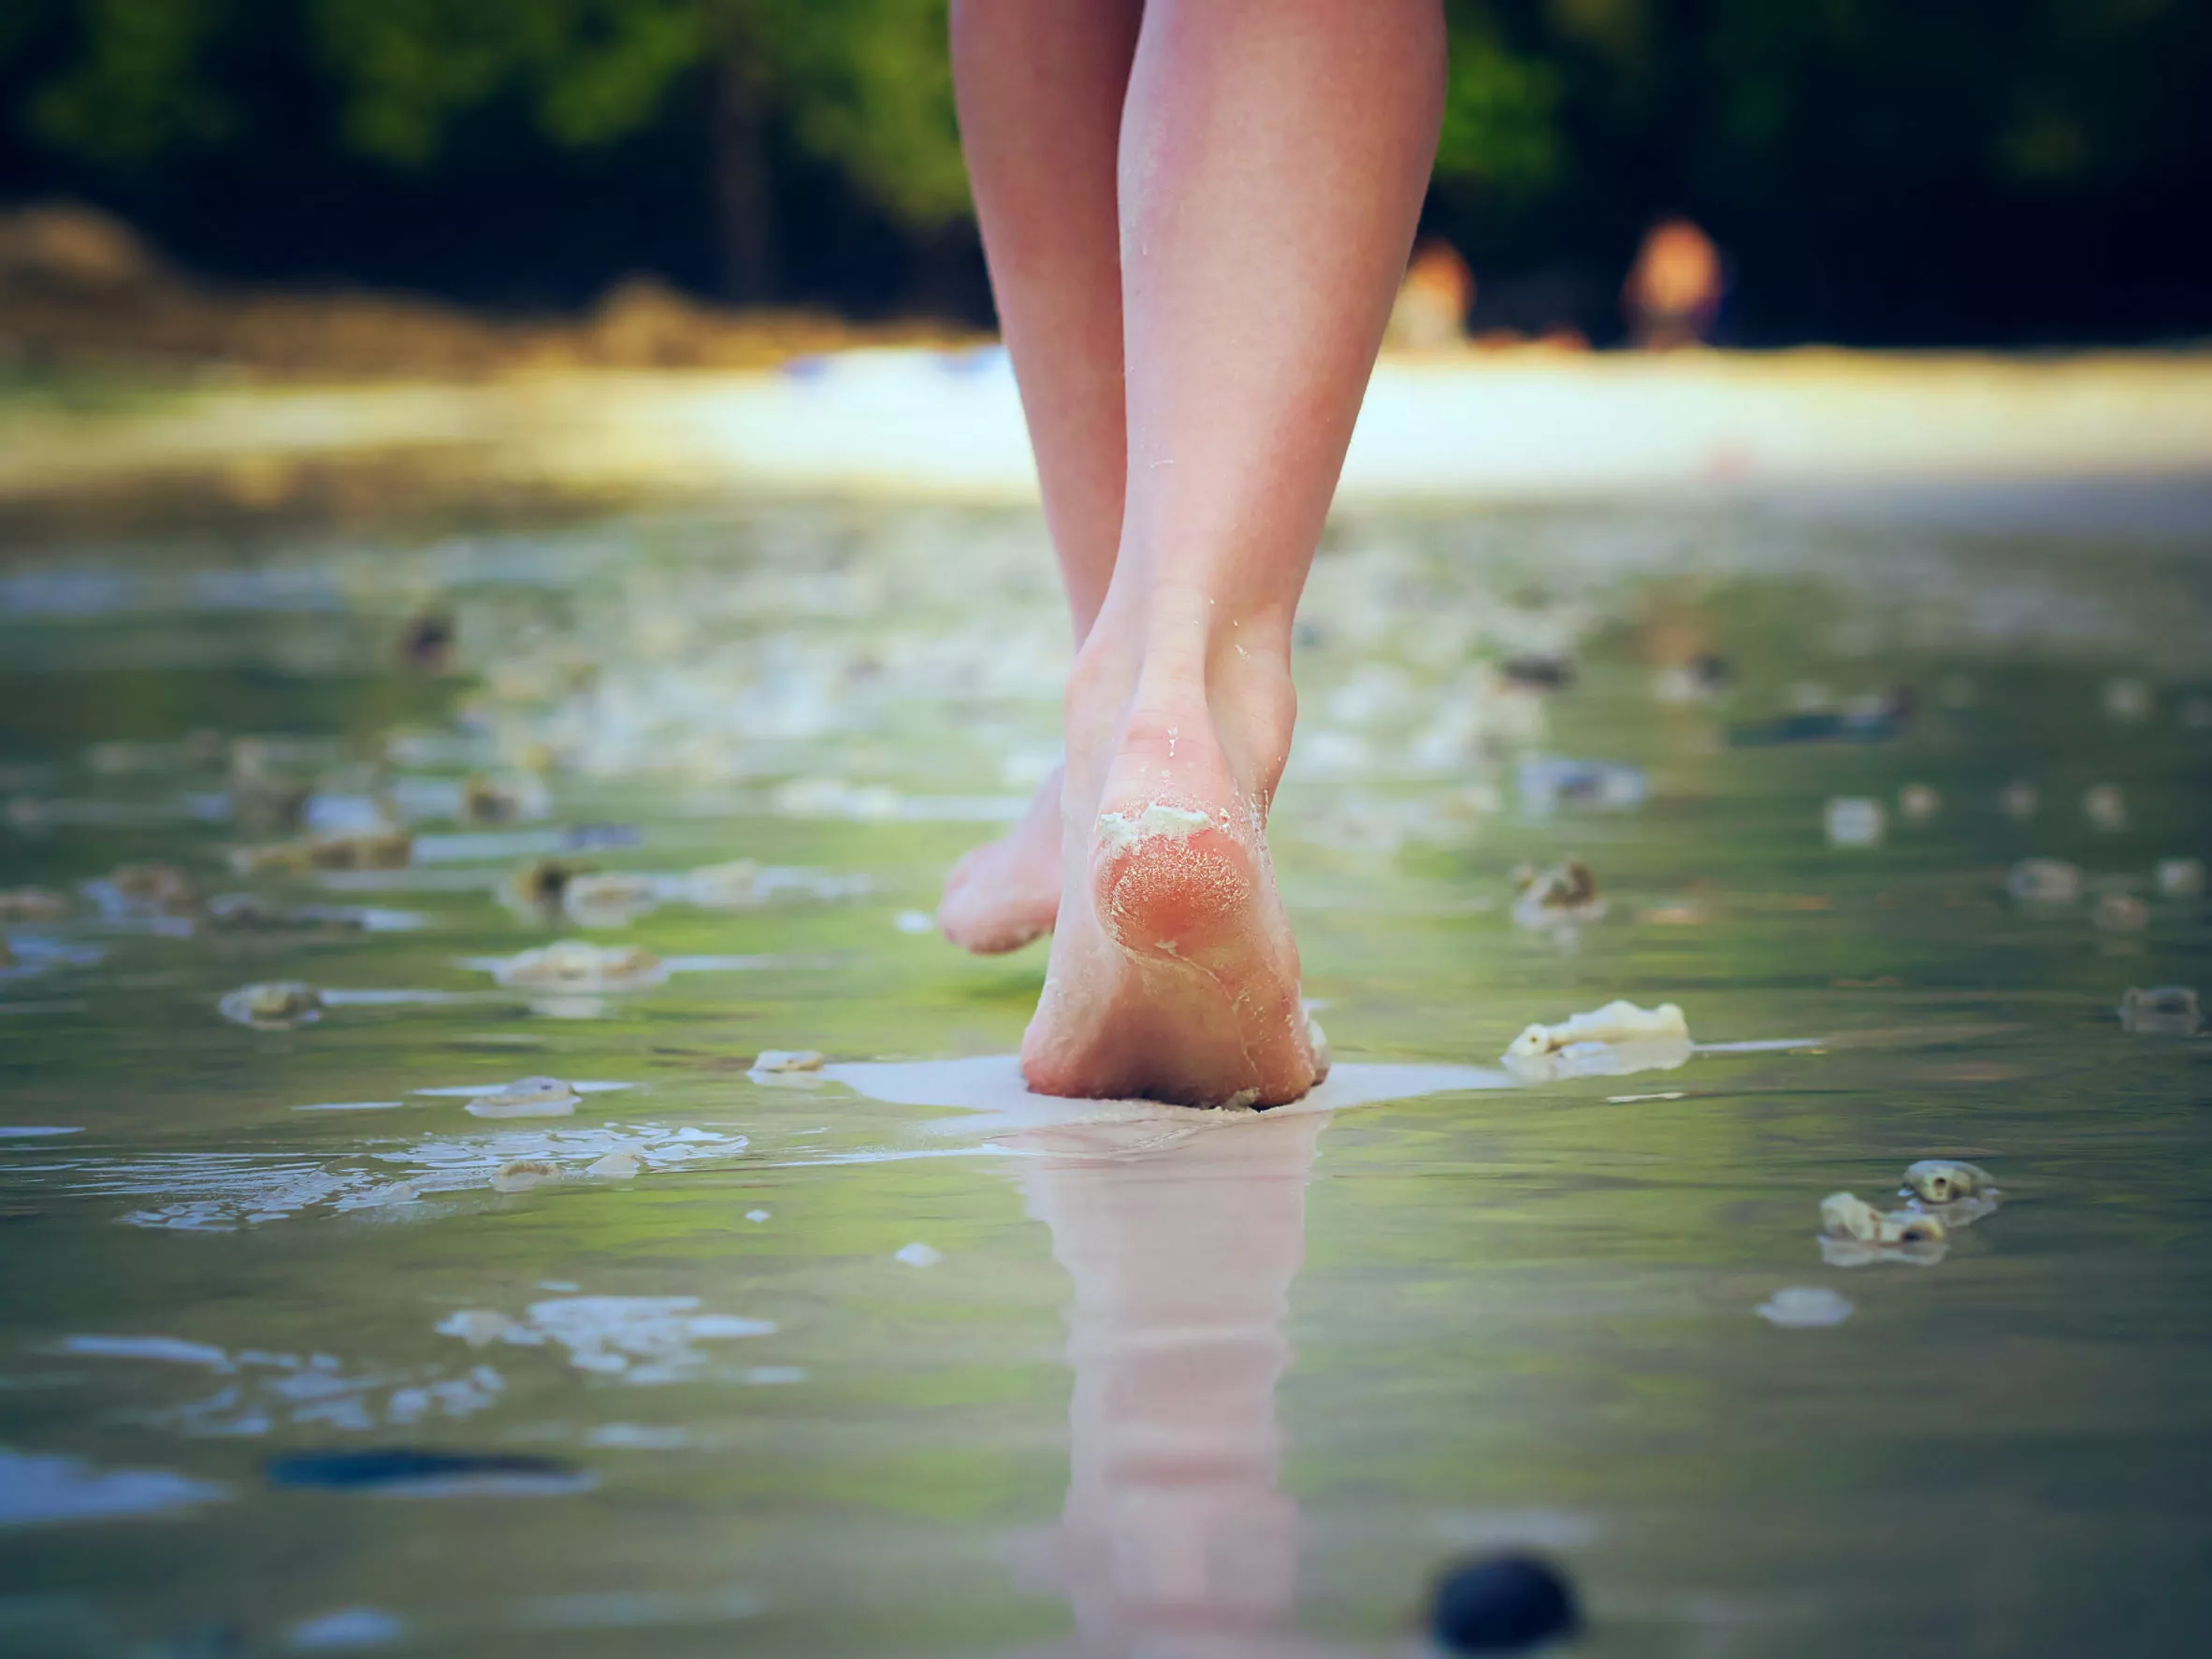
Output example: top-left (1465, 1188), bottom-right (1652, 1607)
top-left (0, 350), bottom-right (2212, 502)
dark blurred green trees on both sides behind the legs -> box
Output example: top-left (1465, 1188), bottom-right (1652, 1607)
top-left (0, 0), bottom-right (2212, 338)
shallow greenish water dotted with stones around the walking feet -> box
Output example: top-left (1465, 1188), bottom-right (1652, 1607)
top-left (0, 507), bottom-right (2212, 1659)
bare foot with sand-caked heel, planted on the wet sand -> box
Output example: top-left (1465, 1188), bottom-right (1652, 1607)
top-left (1022, 646), bottom-right (1325, 1106)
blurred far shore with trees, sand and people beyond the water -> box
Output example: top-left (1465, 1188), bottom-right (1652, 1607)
top-left (0, 0), bottom-right (2212, 520)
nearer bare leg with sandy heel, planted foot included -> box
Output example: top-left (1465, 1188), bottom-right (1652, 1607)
top-left (1022, 0), bottom-right (1444, 1118)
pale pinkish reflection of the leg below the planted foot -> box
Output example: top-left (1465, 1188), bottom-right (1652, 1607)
top-left (1022, 1115), bottom-right (1327, 1654)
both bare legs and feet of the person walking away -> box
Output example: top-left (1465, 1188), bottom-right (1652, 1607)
top-left (938, 0), bottom-right (1444, 1106)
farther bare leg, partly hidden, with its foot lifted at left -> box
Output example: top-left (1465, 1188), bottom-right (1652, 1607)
top-left (938, 0), bottom-right (1144, 953)
